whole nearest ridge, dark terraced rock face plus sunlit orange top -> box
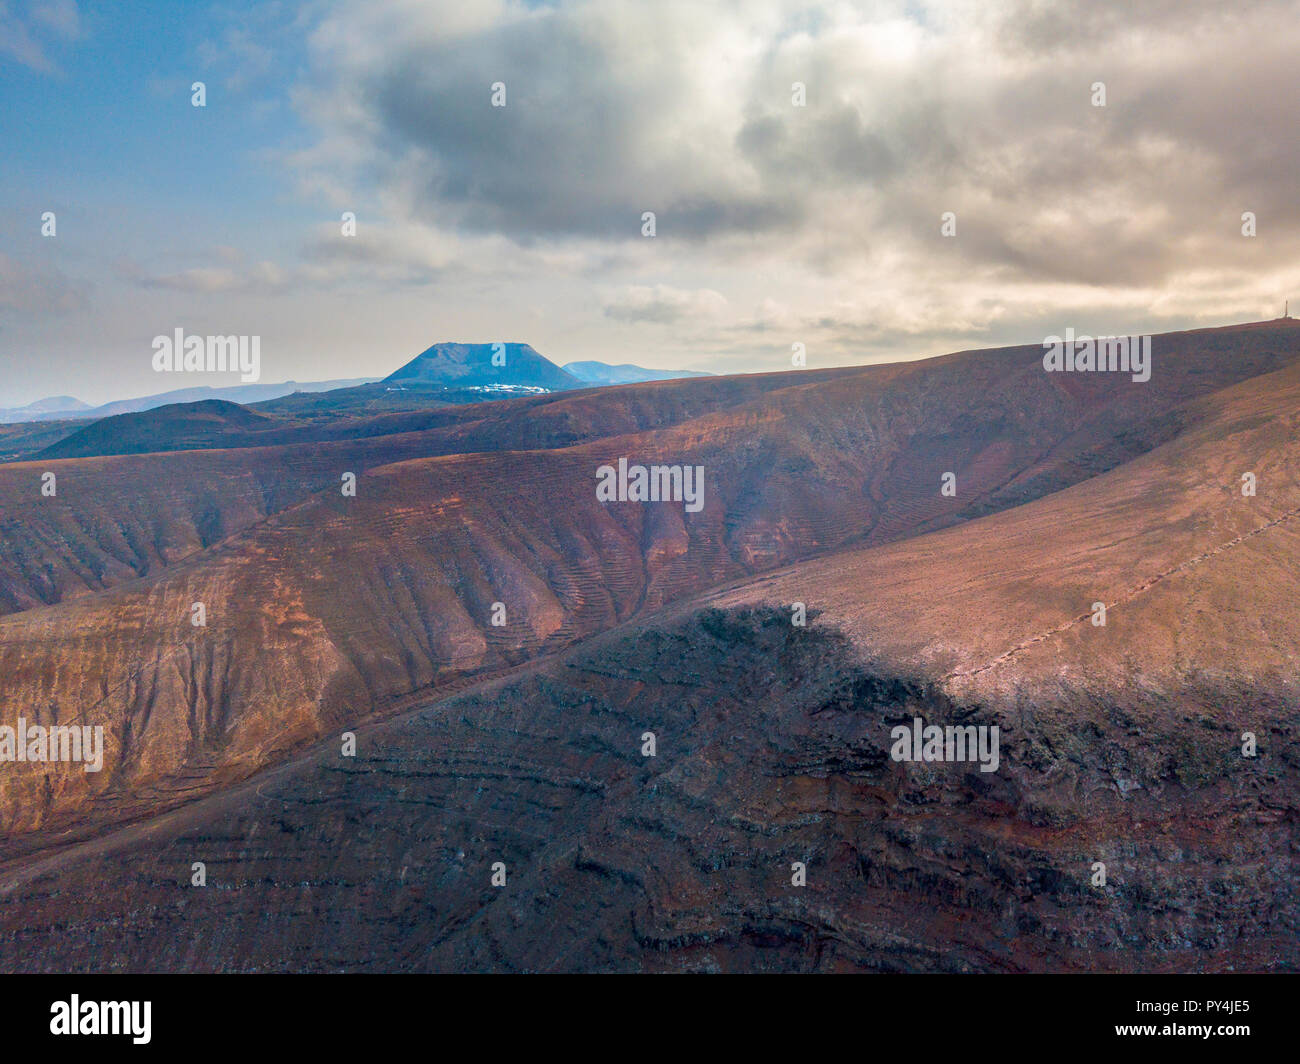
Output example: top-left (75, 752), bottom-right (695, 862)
top-left (0, 351), bottom-right (1300, 972)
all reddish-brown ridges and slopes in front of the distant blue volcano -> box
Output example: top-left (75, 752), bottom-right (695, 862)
top-left (0, 323), bottom-right (1300, 970)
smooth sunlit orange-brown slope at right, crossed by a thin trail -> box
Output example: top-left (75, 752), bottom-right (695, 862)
top-left (716, 351), bottom-right (1300, 697)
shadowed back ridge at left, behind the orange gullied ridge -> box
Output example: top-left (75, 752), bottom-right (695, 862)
top-left (0, 371), bottom-right (852, 614)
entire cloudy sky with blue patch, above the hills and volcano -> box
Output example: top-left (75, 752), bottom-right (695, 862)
top-left (0, 0), bottom-right (1300, 406)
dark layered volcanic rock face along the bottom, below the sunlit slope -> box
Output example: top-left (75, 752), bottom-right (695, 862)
top-left (0, 610), bottom-right (1300, 972)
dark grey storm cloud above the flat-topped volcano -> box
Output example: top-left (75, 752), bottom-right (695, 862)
top-left (330, 6), bottom-right (798, 241)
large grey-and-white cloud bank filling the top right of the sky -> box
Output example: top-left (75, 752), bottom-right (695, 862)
top-left (289, 0), bottom-right (1300, 293)
